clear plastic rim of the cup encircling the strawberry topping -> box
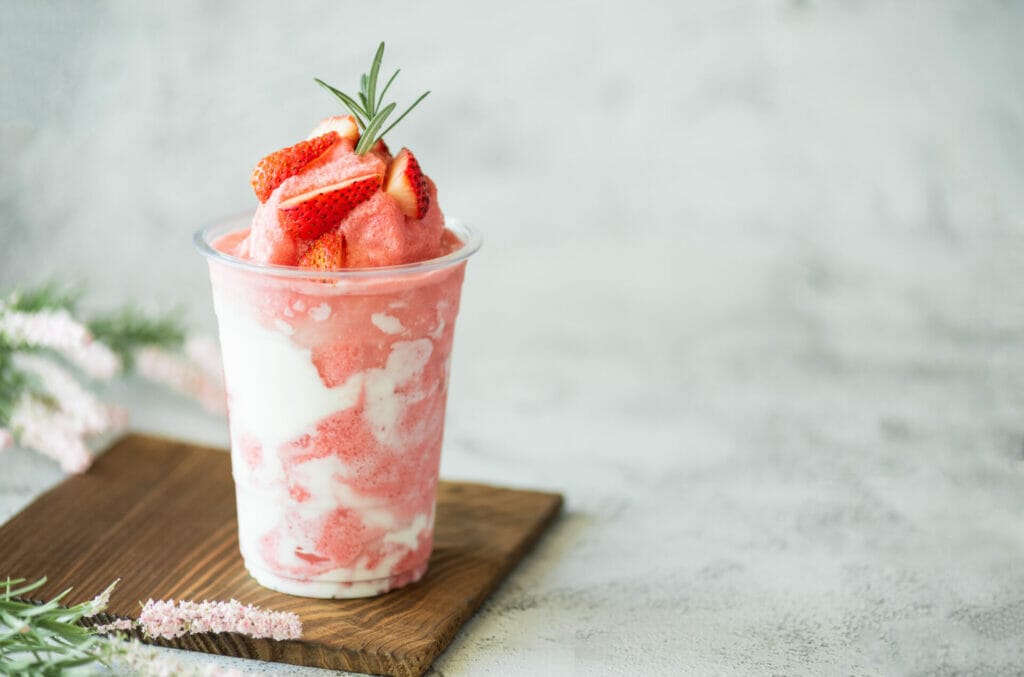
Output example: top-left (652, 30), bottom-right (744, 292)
top-left (193, 212), bottom-right (482, 281)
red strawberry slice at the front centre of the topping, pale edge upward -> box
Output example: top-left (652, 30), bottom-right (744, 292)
top-left (278, 174), bottom-right (381, 240)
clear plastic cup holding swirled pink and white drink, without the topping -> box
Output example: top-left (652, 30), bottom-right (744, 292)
top-left (195, 216), bottom-right (480, 598)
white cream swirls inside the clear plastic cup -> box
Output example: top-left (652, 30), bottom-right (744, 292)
top-left (214, 295), bottom-right (443, 583)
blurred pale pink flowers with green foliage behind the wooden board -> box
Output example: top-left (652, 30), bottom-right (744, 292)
top-left (0, 284), bottom-right (226, 472)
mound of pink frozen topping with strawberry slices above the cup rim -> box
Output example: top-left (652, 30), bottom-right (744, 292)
top-left (227, 116), bottom-right (444, 270)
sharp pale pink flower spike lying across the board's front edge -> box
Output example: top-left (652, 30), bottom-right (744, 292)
top-left (138, 599), bottom-right (302, 639)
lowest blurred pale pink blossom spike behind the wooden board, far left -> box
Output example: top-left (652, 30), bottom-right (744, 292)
top-left (10, 394), bottom-right (92, 473)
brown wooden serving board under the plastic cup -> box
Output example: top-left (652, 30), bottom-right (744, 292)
top-left (0, 435), bottom-right (562, 675)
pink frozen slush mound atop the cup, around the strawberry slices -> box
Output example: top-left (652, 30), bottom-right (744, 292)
top-left (234, 138), bottom-right (444, 268)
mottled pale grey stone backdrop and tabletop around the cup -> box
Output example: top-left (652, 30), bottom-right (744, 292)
top-left (0, 2), bottom-right (1024, 675)
